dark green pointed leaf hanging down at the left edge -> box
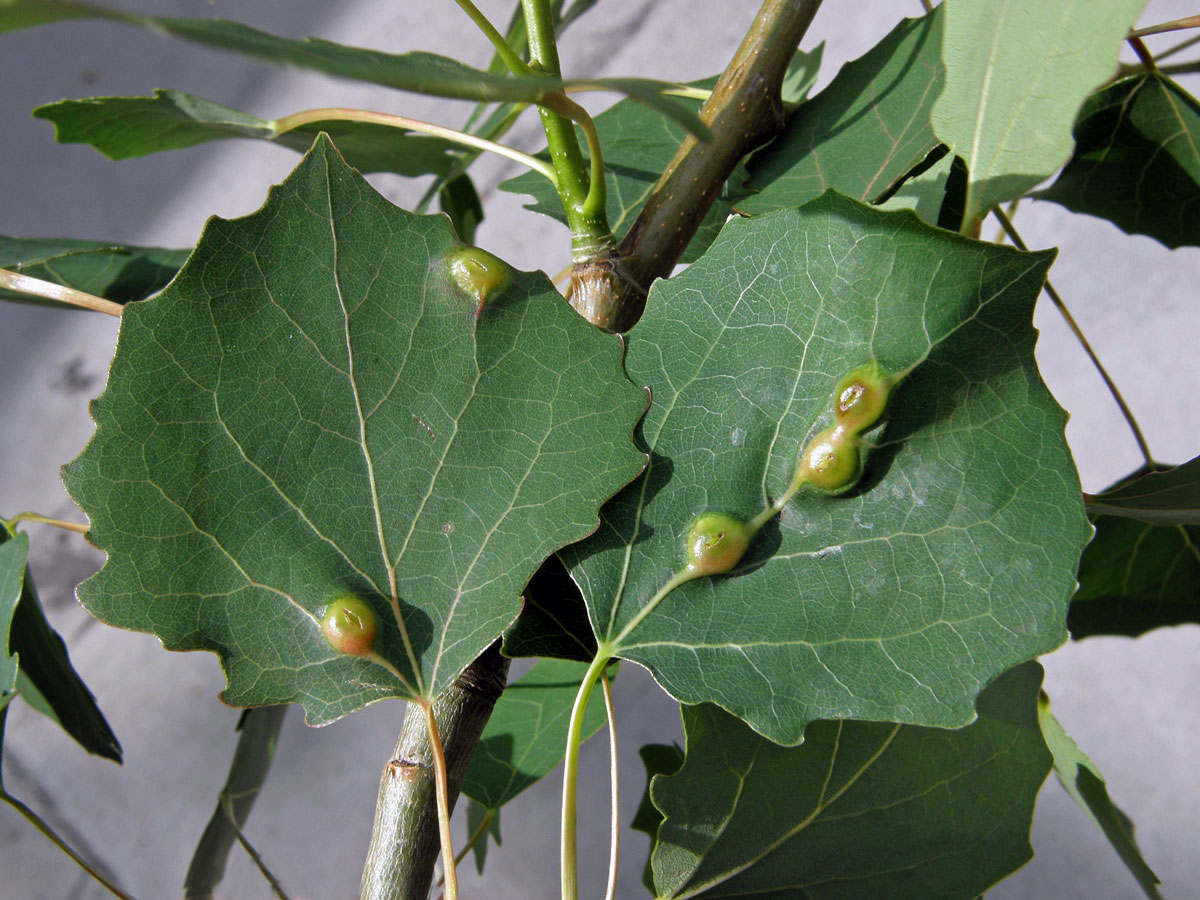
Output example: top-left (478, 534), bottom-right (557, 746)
top-left (0, 526), bottom-right (121, 762)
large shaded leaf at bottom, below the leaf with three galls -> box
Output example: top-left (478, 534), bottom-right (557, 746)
top-left (650, 664), bottom-right (1050, 900)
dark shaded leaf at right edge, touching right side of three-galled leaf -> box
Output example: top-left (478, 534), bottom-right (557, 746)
top-left (1067, 516), bottom-right (1200, 638)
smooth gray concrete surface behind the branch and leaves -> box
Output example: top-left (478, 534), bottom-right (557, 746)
top-left (0, 0), bottom-right (1200, 900)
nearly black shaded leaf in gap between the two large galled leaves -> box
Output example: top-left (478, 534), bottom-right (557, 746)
top-left (502, 556), bottom-right (596, 662)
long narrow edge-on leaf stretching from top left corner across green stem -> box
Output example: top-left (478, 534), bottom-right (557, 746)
top-left (0, 0), bottom-right (708, 137)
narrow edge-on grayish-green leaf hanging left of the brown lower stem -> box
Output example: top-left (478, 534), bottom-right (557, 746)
top-left (184, 706), bottom-right (288, 898)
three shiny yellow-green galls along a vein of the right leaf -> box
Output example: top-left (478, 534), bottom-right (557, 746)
top-left (684, 362), bottom-right (898, 577)
